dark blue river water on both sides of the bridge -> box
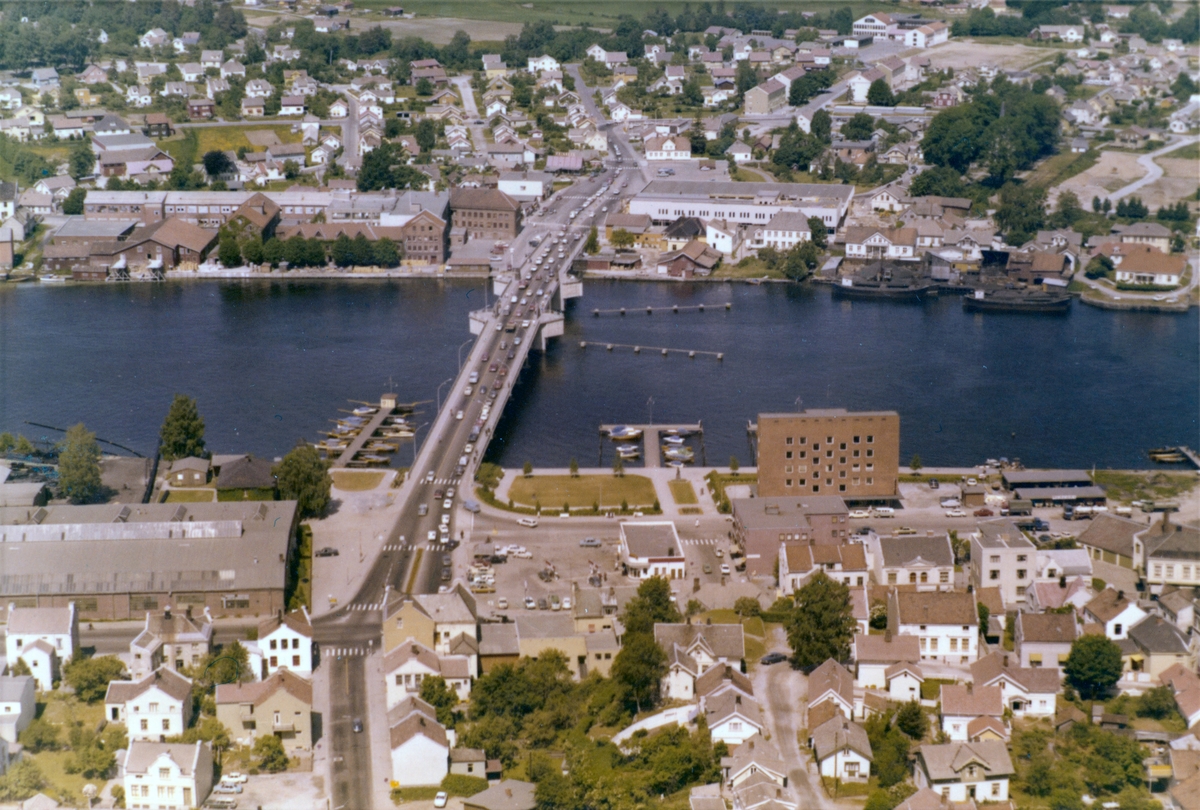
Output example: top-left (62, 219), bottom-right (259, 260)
top-left (0, 281), bottom-right (1200, 468)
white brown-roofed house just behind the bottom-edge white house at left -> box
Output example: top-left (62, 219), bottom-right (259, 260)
top-left (104, 667), bottom-right (192, 742)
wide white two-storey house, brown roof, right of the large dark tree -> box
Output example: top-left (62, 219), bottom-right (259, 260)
top-left (888, 589), bottom-right (979, 664)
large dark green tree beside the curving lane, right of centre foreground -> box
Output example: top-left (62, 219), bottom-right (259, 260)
top-left (786, 571), bottom-right (858, 668)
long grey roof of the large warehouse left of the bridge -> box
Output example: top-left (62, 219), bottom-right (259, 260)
top-left (0, 500), bottom-right (296, 595)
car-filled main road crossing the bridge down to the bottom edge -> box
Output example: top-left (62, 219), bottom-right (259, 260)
top-left (313, 133), bottom-right (641, 808)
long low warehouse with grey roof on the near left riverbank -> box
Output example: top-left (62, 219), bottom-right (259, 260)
top-left (0, 500), bottom-right (299, 620)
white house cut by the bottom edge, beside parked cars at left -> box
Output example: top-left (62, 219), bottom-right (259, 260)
top-left (120, 739), bottom-right (212, 810)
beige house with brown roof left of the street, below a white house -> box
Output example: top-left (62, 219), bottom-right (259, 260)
top-left (216, 670), bottom-right (313, 755)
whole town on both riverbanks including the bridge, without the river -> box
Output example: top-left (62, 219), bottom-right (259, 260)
top-left (0, 0), bottom-right (1200, 810)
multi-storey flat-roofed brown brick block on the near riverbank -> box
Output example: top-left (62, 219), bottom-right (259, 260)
top-left (758, 408), bottom-right (900, 500)
